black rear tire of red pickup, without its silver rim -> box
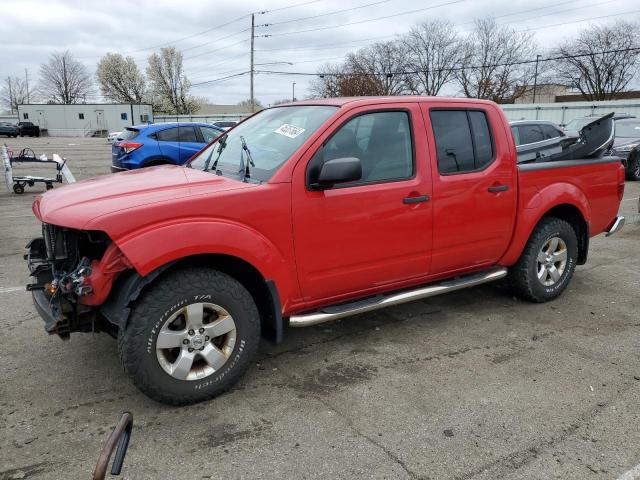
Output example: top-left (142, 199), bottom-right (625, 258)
top-left (508, 217), bottom-right (578, 303)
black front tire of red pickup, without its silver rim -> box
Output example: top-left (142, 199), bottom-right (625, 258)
top-left (118, 267), bottom-right (260, 405)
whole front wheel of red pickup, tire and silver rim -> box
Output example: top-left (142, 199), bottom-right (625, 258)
top-left (118, 268), bottom-right (260, 405)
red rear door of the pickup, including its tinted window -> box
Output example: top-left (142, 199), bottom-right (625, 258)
top-left (422, 102), bottom-right (517, 274)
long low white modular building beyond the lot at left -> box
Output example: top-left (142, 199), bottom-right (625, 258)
top-left (18, 103), bottom-right (153, 137)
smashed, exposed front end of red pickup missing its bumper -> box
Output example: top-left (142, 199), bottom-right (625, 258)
top-left (24, 224), bottom-right (131, 339)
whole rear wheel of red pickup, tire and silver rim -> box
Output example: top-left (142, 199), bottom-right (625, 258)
top-left (509, 217), bottom-right (578, 302)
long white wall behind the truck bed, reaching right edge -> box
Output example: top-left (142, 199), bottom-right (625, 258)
top-left (500, 99), bottom-right (640, 125)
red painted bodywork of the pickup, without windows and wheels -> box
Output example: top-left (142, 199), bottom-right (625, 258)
top-left (33, 97), bottom-right (624, 315)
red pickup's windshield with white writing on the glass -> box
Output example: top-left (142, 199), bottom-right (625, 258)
top-left (190, 105), bottom-right (338, 182)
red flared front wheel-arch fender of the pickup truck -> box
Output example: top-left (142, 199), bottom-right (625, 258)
top-left (116, 218), bottom-right (296, 306)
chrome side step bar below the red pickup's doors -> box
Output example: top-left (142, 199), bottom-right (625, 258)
top-left (289, 268), bottom-right (507, 327)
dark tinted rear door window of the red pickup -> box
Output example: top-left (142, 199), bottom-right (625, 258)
top-left (430, 110), bottom-right (493, 175)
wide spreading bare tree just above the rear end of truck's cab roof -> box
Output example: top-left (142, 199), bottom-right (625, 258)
top-left (456, 18), bottom-right (537, 103)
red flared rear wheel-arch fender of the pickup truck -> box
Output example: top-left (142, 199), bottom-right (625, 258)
top-left (499, 182), bottom-right (591, 266)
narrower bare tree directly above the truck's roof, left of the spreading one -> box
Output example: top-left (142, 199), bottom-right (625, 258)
top-left (402, 20), bottom-right (463, 95)
